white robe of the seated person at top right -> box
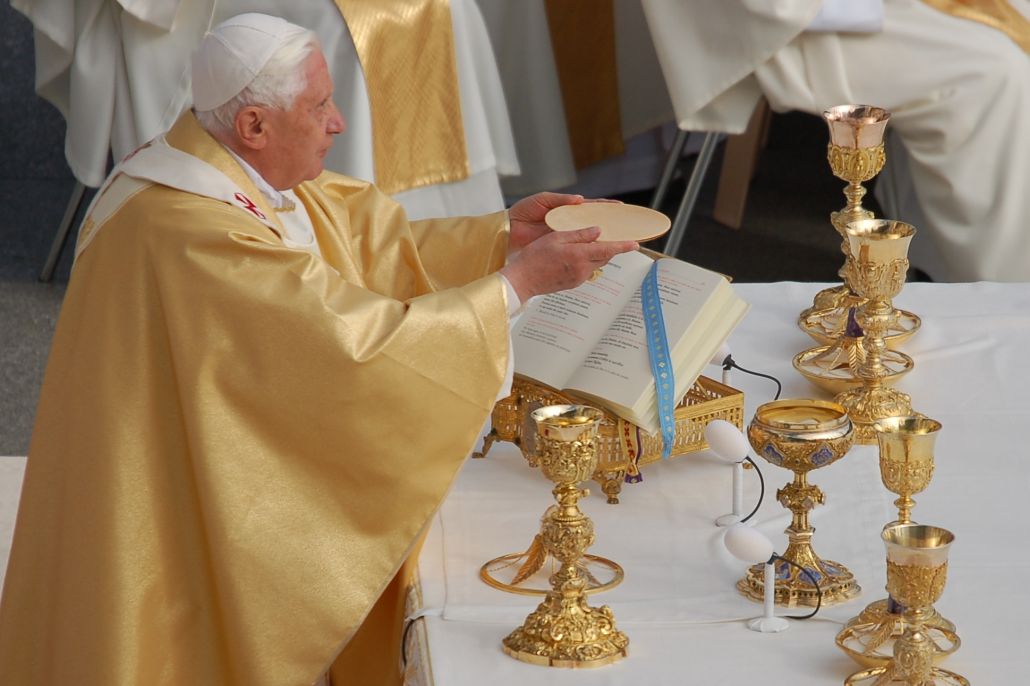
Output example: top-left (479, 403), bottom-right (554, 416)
top-left (643, 0), bottom-right (1030, 281)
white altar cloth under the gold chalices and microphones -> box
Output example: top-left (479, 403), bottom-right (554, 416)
top-left (409, 283), bottom-right (1030, 686)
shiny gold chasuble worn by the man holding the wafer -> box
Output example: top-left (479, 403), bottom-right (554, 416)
top-left (0, 113), bottom-right (508, 686)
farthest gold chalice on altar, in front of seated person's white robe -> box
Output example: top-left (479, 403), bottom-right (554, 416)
top-left (797, 105), bottom-right (920, 350)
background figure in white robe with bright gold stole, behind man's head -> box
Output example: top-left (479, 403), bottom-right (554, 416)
top-left (11, 0), bottom-right (518, 218)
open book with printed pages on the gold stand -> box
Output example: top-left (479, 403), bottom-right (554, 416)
top-left (512, 252), bottom-right (748, 434)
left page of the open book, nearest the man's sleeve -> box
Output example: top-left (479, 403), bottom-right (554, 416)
top-left (512, 251), bottom-right (651, 389)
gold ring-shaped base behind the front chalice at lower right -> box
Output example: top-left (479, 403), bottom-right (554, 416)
top-left (835, 598), bottom-right (962, 667)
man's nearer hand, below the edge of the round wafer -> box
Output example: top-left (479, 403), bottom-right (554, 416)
top-left (501, 226), bottom-right (640, 303)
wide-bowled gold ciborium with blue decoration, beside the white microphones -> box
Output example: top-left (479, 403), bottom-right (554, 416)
top-left (736, 399), bottom-right (860, 607)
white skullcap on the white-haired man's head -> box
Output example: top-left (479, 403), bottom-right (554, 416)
top-left (193, 12), bottom-right (291, 112)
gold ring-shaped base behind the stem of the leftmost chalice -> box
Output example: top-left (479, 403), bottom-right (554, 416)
top-left (479, 537), bottom-right (625, 595)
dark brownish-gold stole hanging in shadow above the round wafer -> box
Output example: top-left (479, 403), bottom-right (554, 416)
top-left (545, 0), bottom-right (625, 169)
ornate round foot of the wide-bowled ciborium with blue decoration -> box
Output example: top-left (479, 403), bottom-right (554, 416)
top-left (736, 559), bottom-right (862, 608)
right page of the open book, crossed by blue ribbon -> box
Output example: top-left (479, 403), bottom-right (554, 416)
top-left (567, 260), bottom-right (735, 431)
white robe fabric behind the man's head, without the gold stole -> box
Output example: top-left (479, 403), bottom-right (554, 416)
top-left (11, 0), bottom-right (518, 219)
